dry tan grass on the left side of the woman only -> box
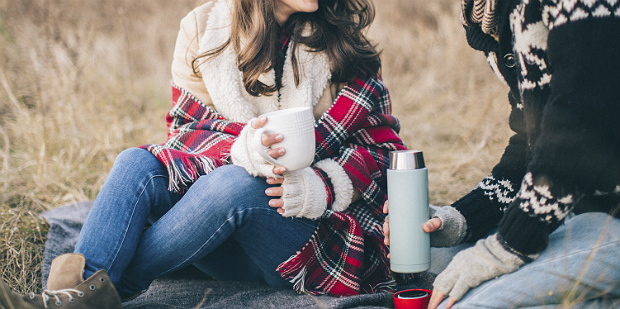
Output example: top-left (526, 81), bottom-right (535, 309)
top-left (0, 0), bottom-right (201, 291)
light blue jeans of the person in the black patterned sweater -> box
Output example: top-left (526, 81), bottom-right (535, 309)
top-left (431, 213), bottom-right (620, 309)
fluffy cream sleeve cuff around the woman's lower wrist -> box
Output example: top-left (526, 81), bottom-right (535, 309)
top-left (314, 159), bottom-right (355, 212)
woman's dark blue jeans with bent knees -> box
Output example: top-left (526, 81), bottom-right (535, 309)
top-left (75, 148), bottom-right (316, 298)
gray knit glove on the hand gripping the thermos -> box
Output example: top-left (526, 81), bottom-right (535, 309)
top-left (428, 205), bottom-right (467, 247)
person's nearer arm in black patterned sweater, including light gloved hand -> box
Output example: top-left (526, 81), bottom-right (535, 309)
top-left (429, 1), bottom-right (620, 309)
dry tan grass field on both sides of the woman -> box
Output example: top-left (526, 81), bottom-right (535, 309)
top-left (0, 0), bottom-right (509, 291)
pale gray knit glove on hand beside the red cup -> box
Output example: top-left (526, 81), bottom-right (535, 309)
top-left (433, 234), bottom-right (538, 301)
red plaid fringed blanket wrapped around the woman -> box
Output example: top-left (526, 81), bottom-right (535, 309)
top-left (141, 78), bottom-right (405, 296)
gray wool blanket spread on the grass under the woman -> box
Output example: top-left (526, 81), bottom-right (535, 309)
top-left (41, 202), bottom-right (434, 309)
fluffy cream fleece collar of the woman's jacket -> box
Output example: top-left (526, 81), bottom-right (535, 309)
top-left (199, 0), bottom-right (331, 122)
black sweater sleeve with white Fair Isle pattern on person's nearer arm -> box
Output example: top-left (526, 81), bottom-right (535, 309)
top-left (499, 0), bottom-right (620, 256)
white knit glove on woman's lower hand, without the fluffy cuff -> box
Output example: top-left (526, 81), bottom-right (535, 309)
top-left (282, 167), bottom-right (327, 219)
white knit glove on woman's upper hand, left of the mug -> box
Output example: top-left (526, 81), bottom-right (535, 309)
top-left (230, 119), bottom-right (281, 178)
